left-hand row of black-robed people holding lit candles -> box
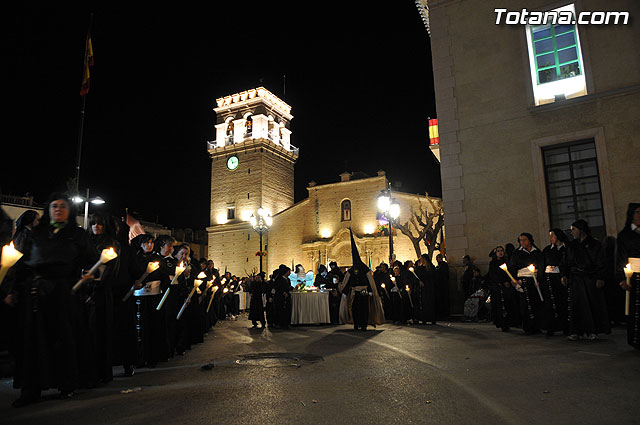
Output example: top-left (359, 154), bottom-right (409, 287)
top-left (0, 193), bottom-right (249, 407)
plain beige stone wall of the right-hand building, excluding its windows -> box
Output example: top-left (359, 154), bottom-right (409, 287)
top-left (429, 0), bottom-right (640, 300)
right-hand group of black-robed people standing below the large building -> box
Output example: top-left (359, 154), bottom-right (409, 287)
top-left (461, 203), bottom-right (640, 348)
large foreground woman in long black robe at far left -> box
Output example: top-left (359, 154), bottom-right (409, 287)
top-left (13, 193), bottom-right (97, 407)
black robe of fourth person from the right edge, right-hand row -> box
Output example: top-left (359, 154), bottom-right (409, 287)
top-left (509, 248), bottom-right (544, 333)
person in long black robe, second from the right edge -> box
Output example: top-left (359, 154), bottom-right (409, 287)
top-left (563, 219), bottom-right (611, 341)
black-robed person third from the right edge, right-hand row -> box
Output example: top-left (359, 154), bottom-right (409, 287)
top-left (540, 229), bottom-right (569, 336)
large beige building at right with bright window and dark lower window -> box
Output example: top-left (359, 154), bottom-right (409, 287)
top-left (416, 0), bottom-right (640, 281)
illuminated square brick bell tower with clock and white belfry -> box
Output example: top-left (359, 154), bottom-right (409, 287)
top-left (207, 87), bottom-right (298, 274)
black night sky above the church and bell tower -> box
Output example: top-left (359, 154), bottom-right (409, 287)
top-left (0, 0), bottom-right (440, 228)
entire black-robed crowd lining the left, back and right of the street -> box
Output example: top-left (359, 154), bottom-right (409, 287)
top-left (0, 193), bottom-right (640, 407)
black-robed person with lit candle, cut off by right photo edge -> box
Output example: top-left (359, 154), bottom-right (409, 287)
top-left (616, 203), bottom-right (640, 349)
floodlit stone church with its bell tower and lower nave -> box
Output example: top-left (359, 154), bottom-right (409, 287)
top-left (207, 87), bottom-right (438, 274)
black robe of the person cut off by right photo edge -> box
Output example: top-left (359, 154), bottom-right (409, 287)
top-left (616, 227), bottom-right (640, 349)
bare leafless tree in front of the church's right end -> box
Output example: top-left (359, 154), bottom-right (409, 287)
top-left (396, 193), bottom-right (444, 260)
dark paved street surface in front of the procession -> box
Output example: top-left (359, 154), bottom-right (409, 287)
top-left (0, 317), bottom-right (640, 425)
